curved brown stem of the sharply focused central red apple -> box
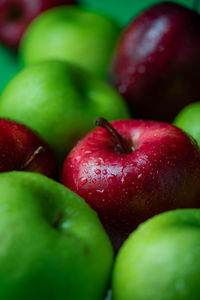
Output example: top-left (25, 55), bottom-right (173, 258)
top-left (95, 118), bottom-right (133, 154)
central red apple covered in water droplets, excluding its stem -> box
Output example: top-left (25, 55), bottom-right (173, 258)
top-left (62, 120), bottom-right (200, 249)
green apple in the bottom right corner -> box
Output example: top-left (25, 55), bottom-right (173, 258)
top-left (112, 209), bottom-right (200, 300)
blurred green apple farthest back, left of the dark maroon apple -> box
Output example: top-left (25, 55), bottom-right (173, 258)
top-left (20, 6), bottom-right (120, 76)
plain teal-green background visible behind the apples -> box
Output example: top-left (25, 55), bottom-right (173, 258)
top-left (0, 0), bottom-right (197, 94)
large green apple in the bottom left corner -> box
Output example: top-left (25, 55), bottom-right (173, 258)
top-left (0, 172), bottom-right (113, 300)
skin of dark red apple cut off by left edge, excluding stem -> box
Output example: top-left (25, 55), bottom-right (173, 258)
top-left (0, 119), bottom-right (58, 178)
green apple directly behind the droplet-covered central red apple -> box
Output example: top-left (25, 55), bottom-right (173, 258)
top-left (0, 61), bottom-right (129, 162)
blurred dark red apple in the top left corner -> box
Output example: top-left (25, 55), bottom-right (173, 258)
top-left (0, 0), bottom-right (76, 50)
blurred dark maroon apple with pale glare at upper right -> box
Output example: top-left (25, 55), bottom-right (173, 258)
top-left (111, 2), bottom-right (200, 121)
